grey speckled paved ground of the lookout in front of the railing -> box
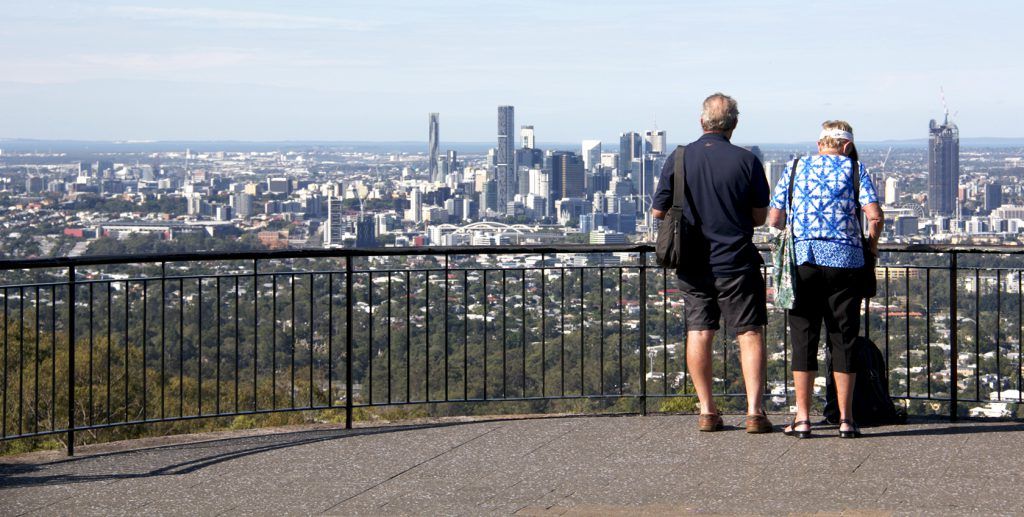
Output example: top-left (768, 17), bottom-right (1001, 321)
top-left (0, 416), bottom-right (1024, 515)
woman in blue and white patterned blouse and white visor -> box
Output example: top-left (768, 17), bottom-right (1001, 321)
top-left (768, 121), bottom-right (884, 438)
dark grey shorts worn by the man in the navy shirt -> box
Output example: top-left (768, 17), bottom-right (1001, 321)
top-left (679, 269), bottom-right (768, 334)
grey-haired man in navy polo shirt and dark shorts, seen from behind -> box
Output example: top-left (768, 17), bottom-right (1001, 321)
top-left (652, 93), bottom-right (772, 433)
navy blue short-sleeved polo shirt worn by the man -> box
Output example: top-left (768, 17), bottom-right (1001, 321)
top-left (652, 133), bottom-right (770, 277)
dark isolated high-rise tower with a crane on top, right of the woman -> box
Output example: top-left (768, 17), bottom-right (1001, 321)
top-left (928, 114), bottom-right (959, 215)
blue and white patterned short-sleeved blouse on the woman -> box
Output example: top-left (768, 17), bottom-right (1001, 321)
top-left (771, 155), bottom-right (879, 267)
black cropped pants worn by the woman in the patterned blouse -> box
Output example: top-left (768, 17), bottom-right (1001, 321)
top-left (790, 264), bottom-right (861, 374)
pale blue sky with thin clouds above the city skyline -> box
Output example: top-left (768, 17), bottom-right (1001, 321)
top-left (0, 0), bottom-right (1024, 147)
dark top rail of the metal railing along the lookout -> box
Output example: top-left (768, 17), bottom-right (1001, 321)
top-left (0, 243), bottom-right (1024, 270)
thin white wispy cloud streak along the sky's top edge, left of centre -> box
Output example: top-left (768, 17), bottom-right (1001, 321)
top-left (109, 5), bottom-right (380, 31)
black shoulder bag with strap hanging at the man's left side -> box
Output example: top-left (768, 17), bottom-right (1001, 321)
top-left (654, 145), bottom-right (710, 271)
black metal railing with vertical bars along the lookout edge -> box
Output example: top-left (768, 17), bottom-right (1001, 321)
top-left (0, 245), bottom-right (1024, 454)
